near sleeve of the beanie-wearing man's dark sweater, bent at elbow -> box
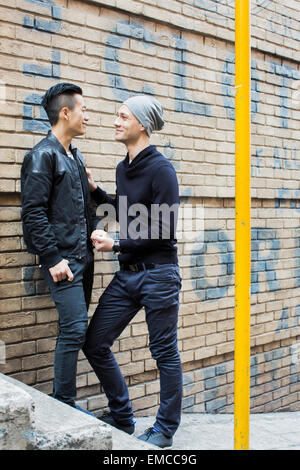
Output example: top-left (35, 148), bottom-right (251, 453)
top-left (120, 165), bottom-right (179, 253)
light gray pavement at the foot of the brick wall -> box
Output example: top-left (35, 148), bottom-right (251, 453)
top-left (134, 411), bottom-right (300, 450)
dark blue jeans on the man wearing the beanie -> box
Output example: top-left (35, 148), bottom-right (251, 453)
top-left (83, 264), bottom-right (182, 436)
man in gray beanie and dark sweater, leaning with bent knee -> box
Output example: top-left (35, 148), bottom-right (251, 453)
top-left (83, 95), bottom-right (182, 447)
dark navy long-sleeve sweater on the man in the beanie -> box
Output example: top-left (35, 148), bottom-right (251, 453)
top-left (91, 145), bottom-right (179, 264)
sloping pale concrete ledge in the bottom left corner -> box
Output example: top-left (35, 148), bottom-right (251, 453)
top-left (0, 374), bottom-right (158, 450)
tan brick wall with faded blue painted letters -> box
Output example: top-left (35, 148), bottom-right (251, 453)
top-left (0, 0), bottom-right (300, 414)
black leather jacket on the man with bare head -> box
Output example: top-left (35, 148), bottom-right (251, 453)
top-left (21, 132), bottom-right (98, 267)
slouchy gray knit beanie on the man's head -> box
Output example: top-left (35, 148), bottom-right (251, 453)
top-left (123, 95), bottom-right (164, 137)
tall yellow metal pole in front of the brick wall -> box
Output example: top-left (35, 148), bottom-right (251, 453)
top-left (234, 0), bottom-right (251, 450)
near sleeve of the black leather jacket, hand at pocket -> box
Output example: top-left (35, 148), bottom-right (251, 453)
top-left (21, 151), bottom-right (63, 267)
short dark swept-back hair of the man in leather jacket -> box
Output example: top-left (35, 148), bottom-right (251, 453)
top-left (41, 82), bottom-right (82, 126)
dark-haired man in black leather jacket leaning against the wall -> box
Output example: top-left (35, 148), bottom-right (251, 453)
top-left (21, 83), bottom-right (98, 408)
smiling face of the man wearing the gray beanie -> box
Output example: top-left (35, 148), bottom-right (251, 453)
top-left (115, 104), bottom-right (144, 144)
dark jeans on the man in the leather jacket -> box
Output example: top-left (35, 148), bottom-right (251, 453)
top-left (41, 252), bottom-right (94, 406)
